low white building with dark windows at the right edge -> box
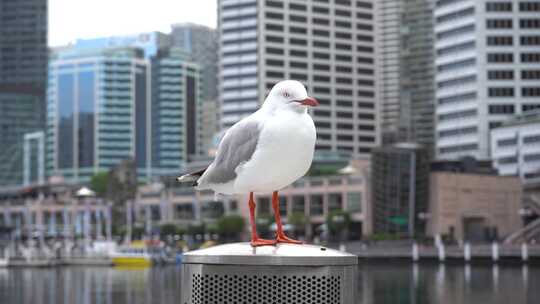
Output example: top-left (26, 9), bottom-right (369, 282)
top-left (491, 111), bottom-right (540, 186)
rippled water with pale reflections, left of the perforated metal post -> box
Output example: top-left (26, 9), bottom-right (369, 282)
top-left (0, 267), bottom-right (180, 304)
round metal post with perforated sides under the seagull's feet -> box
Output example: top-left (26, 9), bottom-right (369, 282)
top-left (181, 243), bottom-right (358, 304)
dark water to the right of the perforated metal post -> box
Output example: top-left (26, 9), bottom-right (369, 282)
top-left (359, 264), bottom-right (540, 304)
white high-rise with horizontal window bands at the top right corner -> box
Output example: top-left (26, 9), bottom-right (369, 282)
top-left (434, 0), bottom-right (540, 159)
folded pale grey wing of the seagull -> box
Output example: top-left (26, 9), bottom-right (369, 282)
top-left (201, 120), bottom-right (260, 184)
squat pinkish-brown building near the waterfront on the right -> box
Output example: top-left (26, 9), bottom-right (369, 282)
top-left (425, 159), bottom-right (523, 242)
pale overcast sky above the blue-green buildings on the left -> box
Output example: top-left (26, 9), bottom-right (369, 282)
top-left (49, 0), bottom-right (217, 46)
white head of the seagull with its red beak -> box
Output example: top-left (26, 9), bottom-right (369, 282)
top-left (263, 80), bottom-right (319, 111)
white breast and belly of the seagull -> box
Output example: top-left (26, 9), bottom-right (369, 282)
top-left (234, 111), bottom-right (316, 193)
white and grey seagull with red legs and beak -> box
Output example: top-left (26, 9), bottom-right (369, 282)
top-left (178, 80), bottom-right (319, 247)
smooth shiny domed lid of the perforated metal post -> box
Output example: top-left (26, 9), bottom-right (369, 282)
top-left (182, 242), bottom-right (358, 266)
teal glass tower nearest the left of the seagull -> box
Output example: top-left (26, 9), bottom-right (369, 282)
top-left (151, 48), bottom-right (203, 176)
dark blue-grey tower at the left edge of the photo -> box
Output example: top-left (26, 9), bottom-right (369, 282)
top-left (0, 0), bottom-right (47, 185)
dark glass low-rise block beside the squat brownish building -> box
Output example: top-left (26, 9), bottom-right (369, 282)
top-left (371, 143), bottom-right (430, 237)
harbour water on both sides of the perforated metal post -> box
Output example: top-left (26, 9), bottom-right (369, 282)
top-left (0, 263), bottom-right (540, 304)
